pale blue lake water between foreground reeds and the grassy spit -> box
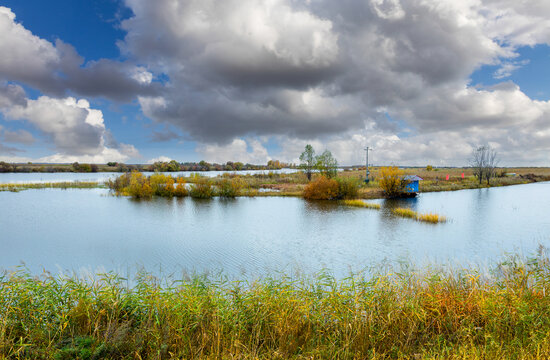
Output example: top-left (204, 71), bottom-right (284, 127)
top-left (0, 179), bottom-right (550, 277)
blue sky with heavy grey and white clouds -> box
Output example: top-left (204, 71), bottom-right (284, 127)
top-left (0, 0), bottom-right (550, 166)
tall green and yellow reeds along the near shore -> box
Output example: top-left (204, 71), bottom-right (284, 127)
top-left (0, 256), bottom-right (550, 359)
